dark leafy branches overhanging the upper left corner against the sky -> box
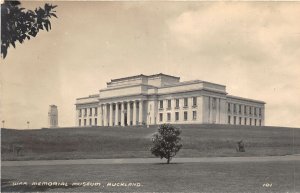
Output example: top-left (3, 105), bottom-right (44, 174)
top-left (1, 0), bottom-right (57, 58)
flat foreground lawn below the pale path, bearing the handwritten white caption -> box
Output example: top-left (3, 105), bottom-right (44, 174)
top-left (1, 161), bottom-right (300, 193)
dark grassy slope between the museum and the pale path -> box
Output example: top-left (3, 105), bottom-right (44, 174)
top-left (1, 125), bottom-right (300, 160)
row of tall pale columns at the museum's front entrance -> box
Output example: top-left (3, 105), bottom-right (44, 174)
top-left (100, 100), bottom-right (144, 126)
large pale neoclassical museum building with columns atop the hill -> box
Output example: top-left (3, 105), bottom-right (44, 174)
top-left (75, 73), bottom-right (265, 126)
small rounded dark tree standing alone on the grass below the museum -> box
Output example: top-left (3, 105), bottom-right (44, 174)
top-left (150, 124), bottom-right (182, 164)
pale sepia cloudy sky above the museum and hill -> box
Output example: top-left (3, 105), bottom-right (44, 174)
top-left (0, 1), bottom-right (300, 129)
